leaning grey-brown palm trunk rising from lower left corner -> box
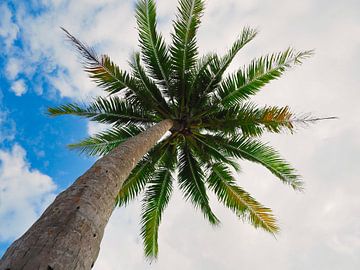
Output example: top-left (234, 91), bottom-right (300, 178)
top-left (0, 120), bottom-right (173, 270)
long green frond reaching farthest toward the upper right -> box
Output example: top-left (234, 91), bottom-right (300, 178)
top-left (217, 48), bottom-right (313, 108)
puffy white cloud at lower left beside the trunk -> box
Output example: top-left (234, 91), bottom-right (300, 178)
top-left (0, 144), bottom-right (56, 241)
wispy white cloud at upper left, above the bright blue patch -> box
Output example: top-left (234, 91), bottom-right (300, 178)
top-left (0, 0), bottom-right (136, 100)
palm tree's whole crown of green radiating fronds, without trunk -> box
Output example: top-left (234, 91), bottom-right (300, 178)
top-left (49, 0), bottom-right (326, 258)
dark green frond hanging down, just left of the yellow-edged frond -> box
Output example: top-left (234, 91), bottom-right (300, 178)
top-left (178, 143), bottom-right (219, 225)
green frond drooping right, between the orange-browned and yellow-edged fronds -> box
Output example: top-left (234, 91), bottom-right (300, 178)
top-left (206, 135), bottom-right (303, 190)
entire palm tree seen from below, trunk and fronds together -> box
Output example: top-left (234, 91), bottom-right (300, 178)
top-left (0, 0), bottom-right (334, 270)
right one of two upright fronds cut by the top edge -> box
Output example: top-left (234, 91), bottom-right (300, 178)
top-left (170, 0), bottom-right (204, 111)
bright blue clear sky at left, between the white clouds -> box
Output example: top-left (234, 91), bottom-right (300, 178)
top-left (0, 1), bottom-right (92, 254)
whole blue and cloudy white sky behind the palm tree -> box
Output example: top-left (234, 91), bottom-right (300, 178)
top-left (0, 0), bottom-right (360, 270)
